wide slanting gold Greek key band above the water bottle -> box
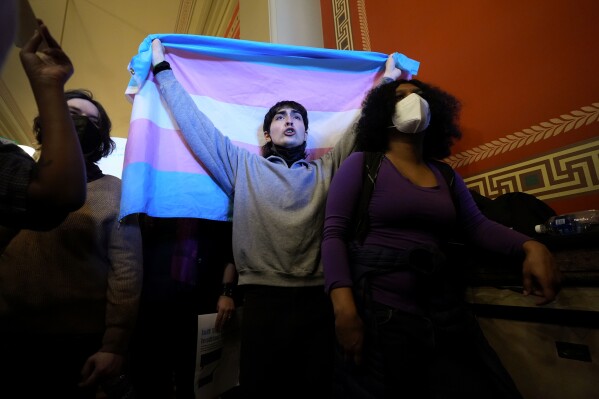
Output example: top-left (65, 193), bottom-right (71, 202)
top-left (464, 138), bottom-right (599, 200)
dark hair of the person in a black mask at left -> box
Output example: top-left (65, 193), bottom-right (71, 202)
top-left (33, 89), bottom-right (116, 162)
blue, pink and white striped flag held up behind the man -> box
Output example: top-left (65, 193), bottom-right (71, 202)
top-left (120, 35), bottom-right (418, 221)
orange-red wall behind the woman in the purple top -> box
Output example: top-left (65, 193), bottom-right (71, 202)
top-left (321, 0), bottom-right (599, 216)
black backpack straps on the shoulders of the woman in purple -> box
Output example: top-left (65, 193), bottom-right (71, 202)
top-left (354, 152), bottom-right (459, 243)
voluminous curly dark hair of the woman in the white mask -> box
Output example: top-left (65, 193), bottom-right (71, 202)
top-left (356, 79), bottom-right (462, 159)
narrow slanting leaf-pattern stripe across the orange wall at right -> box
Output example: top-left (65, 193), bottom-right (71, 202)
top-left (445, 103), bottom-right (599, 168)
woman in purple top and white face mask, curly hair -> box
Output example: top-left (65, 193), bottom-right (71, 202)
top-left (322, 80), bottom-right (560, 399)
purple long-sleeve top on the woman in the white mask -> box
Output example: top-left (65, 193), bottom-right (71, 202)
top-left (322, 152), bottom-right (530, 311)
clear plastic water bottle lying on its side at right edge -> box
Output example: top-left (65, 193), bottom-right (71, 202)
top-left (535, 209), bottom-right (599, 235)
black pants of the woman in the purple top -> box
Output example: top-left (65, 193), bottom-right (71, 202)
top-left (337, 303), bottom-right (521, 399)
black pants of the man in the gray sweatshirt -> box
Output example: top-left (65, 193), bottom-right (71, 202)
top-left (240, 285), bottom-right (334, 398)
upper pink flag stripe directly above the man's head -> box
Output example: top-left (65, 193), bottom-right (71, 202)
top-left (158, 49), bottom-right (382, 112)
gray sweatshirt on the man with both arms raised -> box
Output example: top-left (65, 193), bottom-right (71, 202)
top-left (156, 70), bottom-right (355, 287)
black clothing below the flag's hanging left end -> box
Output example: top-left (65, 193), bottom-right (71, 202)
top-left (130, 215), bottom-right (231, 399)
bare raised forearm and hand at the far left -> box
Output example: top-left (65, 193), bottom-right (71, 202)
top-left (20, 23), bottom-right (87, 222)
